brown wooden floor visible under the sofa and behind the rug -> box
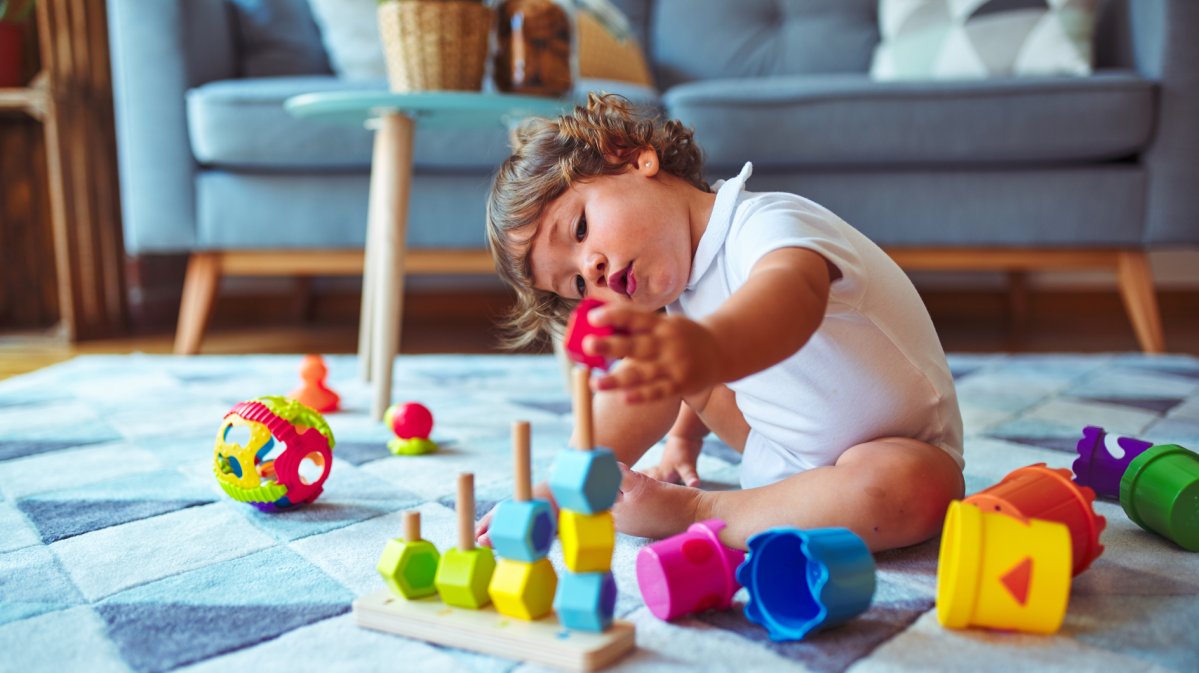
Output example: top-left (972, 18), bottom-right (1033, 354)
top-left (0, 292), bottom-right (1199, 379)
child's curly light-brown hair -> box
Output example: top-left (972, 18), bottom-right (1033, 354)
top-left (487, 94), bottom-right (711, 349)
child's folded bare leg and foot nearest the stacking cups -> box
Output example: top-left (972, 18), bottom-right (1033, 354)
top-left (613, 438), bottom-right (964, 551)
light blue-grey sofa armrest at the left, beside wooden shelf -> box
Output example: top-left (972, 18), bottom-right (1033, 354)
top-left (108, 0), bottom-right (237, 254)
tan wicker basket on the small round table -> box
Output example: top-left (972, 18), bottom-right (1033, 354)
top-left (379, 0), bottom-right (492, 92)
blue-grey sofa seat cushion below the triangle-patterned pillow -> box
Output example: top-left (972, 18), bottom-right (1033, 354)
top-left (663, 71), bottom-right (1156, 167)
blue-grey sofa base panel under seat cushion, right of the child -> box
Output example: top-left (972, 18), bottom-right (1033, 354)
top-left (743, 163), bottom-right (1146, 247)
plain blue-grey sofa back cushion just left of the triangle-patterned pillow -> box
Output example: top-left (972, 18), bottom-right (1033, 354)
top-left (646, 0), bottom-right (879, 89)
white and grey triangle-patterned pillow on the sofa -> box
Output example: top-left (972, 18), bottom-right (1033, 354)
top-left (870, 0), bottom-right (1098, 80)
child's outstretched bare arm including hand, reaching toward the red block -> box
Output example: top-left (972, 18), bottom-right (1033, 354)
top-left (583, 247), bottom-right (836, 402)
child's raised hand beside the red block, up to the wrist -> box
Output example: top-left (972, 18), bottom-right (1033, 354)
top-left (583, 305), bottom-right (719, 402)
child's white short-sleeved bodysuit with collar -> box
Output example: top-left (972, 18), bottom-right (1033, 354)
top-left (667, 163), bottom-right (965, 488)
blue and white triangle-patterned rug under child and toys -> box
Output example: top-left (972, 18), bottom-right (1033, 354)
top-left (0, 355), bottom-right (1199, 673)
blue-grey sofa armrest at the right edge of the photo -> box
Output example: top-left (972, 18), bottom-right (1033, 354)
top-left (1121, 0), bottom-right (1199, 245)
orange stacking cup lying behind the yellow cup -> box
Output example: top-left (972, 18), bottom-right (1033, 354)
top-left (963, 463), bottom-right (1108, 576)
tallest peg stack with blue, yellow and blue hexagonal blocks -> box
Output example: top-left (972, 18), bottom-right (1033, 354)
top-left (549, 368), bottom-right (621, 631)
